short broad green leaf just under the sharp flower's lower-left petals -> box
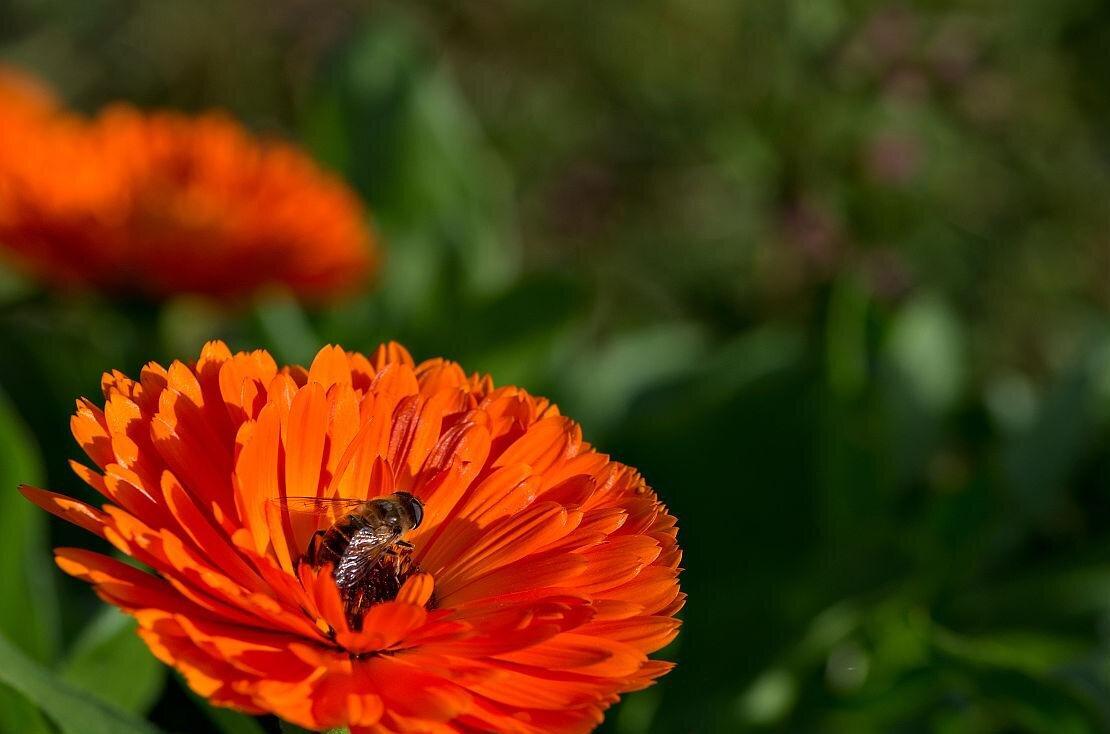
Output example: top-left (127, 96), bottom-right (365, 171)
top-left (59, 606), bottom-right (167, 714)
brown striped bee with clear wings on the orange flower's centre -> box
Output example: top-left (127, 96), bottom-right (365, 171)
top-left (269, 492), bottom-right (424, 630)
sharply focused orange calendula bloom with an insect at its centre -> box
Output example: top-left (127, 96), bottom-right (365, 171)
top-left (23, 342), bottom-right (684, 734)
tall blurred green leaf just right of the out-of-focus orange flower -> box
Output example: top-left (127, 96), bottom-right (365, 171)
top-left (302, 10), bottom-right (519, 319)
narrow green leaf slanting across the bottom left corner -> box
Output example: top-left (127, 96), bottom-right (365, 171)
top-left (0, 636), bottom-right (159, 734)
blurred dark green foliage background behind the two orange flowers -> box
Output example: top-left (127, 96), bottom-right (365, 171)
top-left (0, 0), bottom-right (1110, 734)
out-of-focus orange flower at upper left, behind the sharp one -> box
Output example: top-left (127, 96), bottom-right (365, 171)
top-left (0, 69), bottom-right (375, 298)
